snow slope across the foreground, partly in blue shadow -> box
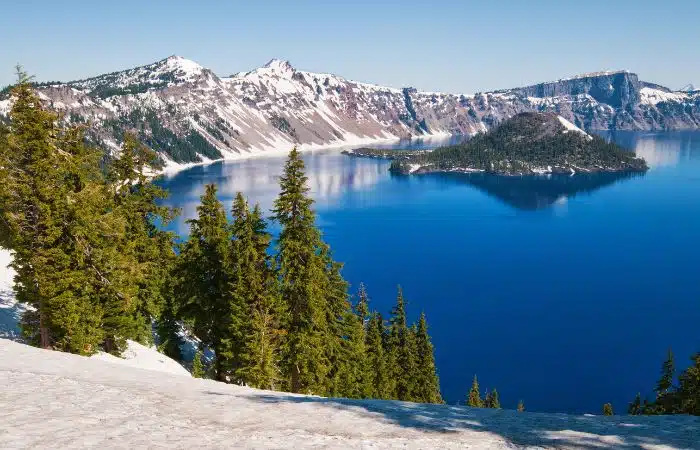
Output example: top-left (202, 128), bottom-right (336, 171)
top-left (0, 339), bottom-right (700, 449)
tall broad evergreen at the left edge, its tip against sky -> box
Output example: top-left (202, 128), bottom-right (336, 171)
top-left (0, 74), bottom-right (104, 354)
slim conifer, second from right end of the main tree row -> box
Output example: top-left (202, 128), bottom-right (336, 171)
top-left (389, 286), bottom-right (415, 401)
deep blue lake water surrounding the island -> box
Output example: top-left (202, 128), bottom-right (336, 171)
top-left (156, 133), bottom-right (700, 413)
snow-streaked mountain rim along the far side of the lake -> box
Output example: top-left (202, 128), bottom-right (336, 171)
top-left (0, 56), bottom-right (700, 169)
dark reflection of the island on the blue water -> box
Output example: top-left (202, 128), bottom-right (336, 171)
top-left (440, 172), bottom-right (644, 211)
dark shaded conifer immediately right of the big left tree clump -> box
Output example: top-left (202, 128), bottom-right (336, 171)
top-left (176, 185), bottom-right (234, 381)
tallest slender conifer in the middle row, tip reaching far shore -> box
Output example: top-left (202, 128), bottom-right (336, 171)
top-left (273, 148), bottom-right (330, 393)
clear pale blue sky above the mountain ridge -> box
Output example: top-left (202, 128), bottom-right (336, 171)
top-left (0, 0), bottom-right (700, 93)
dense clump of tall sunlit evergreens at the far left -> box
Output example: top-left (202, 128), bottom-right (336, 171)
top-left (0, 81), bottom-right (173, 354)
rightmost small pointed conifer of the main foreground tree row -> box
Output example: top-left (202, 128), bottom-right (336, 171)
top-left (414, 313), bottom-right (442, 403)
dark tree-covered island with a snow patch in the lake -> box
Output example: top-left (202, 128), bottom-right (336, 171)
top-left (345, 112), bottom-right (648, 176)
